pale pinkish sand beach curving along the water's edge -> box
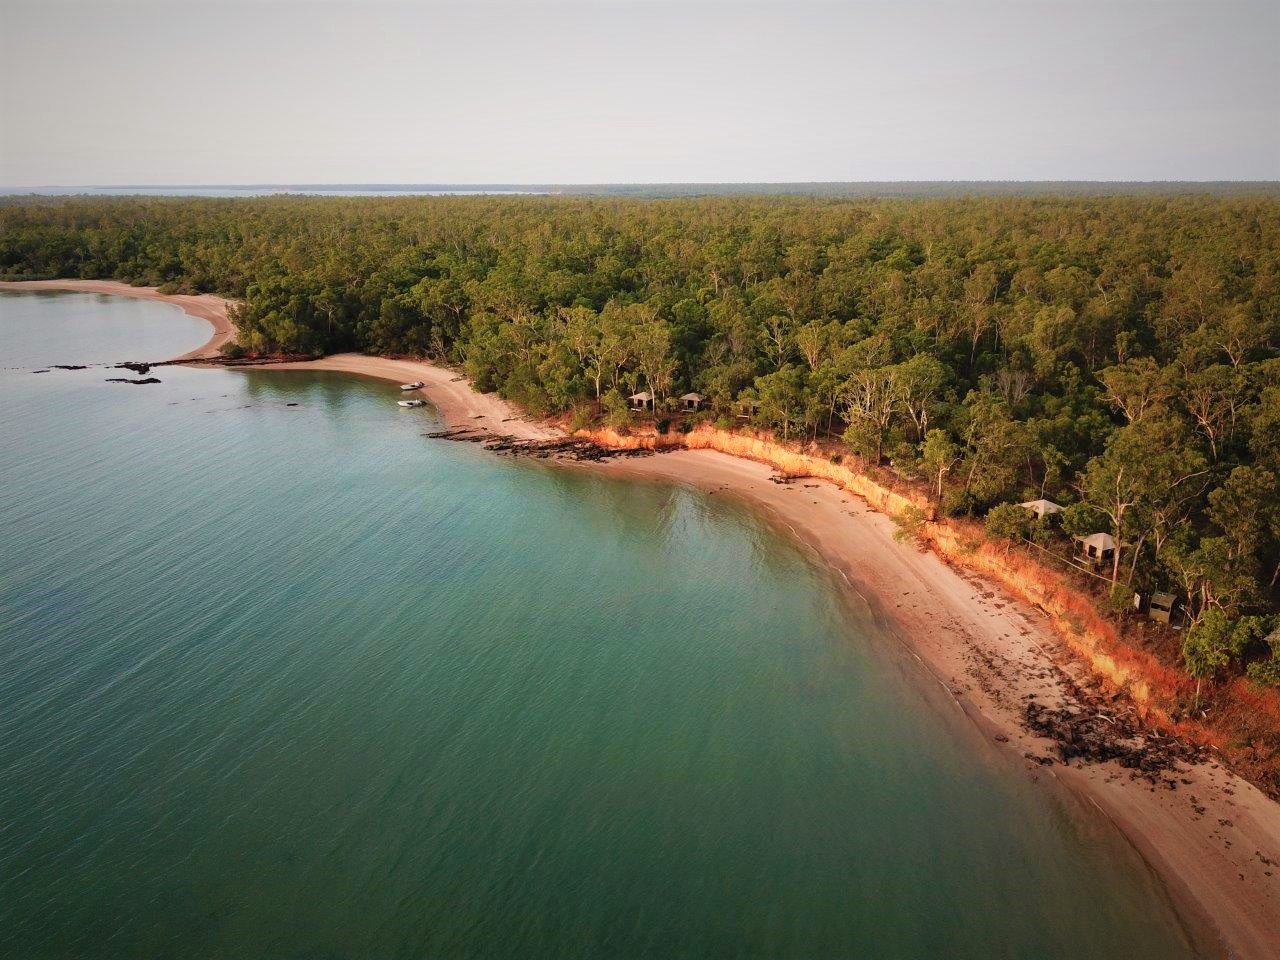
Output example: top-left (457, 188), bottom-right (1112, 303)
top-left (10, 280), bottom-right (1280, 959)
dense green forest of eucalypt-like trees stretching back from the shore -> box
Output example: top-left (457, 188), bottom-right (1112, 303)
top-left (0, 196), bottom-right (1280, 684)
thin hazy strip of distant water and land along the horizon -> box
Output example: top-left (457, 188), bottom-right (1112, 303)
top-left (0, 180), bottom-right (1280, 198)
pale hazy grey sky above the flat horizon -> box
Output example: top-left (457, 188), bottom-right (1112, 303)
top-left (0, 0), bottom-right (1280, 186)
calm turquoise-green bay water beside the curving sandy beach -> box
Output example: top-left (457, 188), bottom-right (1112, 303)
top-left (0, 294), bottom-right (1190, 960)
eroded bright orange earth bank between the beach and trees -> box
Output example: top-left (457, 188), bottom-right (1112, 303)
top-left (577, 425), bottom-right (1280, 796)
